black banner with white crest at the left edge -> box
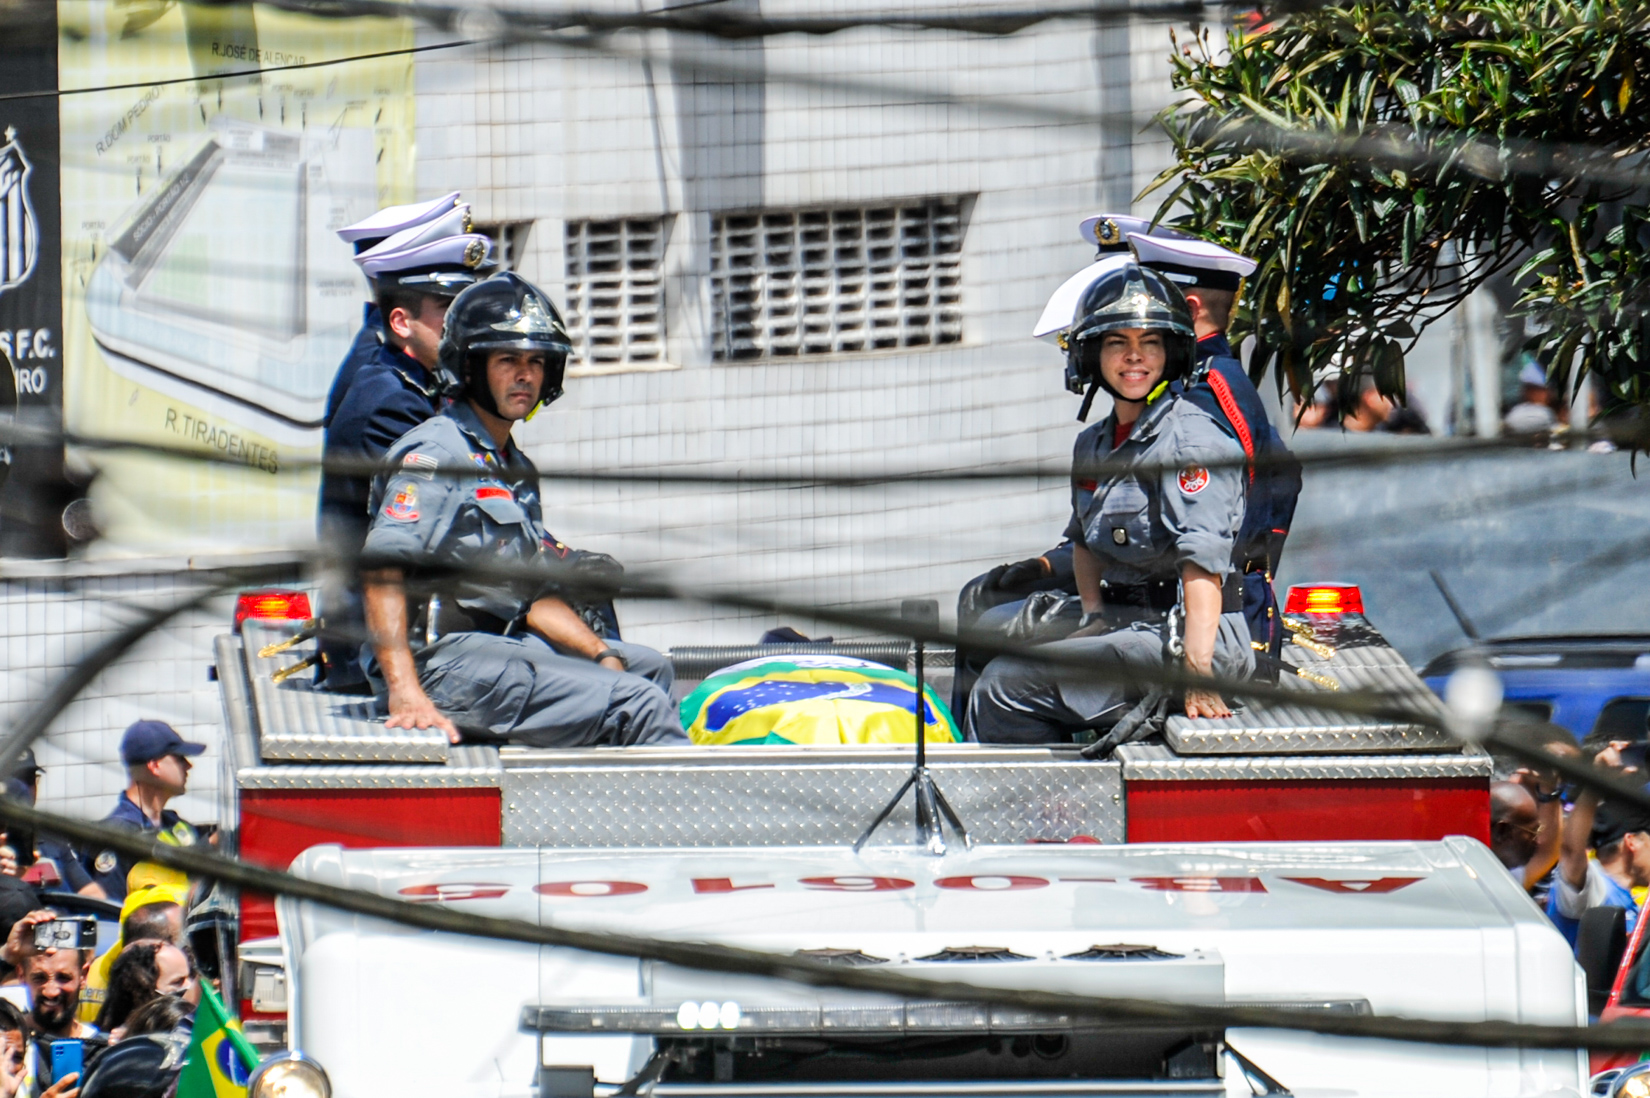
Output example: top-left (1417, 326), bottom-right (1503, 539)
top-left (0, 0), bottom-right (68, 556)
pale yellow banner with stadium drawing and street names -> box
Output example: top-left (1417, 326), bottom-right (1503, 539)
top-left (58, 0), bottom-right (414, 553)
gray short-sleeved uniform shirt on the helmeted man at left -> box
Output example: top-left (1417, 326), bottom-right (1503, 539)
top-left (361, 401), bottom-right (568, 621)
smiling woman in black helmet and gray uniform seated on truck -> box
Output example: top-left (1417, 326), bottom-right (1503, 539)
top-left (969, 263), bottom-right (1254, 743)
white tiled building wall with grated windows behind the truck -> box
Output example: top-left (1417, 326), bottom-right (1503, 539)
top-left (0, 10), bottom-right (1170, 821)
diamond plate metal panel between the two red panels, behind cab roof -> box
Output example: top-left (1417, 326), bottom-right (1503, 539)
top-left (503, 748), bottom-right (1124, 847)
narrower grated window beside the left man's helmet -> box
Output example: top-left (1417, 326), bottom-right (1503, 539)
top-left (566, 218), bottom-right (668, 367)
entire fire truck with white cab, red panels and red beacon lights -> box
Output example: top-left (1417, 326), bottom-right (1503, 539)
top-left (216, 584), bottom-right (1557, 1098)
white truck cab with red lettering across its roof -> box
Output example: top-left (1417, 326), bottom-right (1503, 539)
top-left (279, 835), bottom-right (1587, 1098)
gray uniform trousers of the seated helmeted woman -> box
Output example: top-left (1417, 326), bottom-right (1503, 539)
top-left (969, 613), bottom-right (1254, 743)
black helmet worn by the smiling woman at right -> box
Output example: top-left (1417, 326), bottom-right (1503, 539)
top-left (1064, 263), bottom-right (1196, 419)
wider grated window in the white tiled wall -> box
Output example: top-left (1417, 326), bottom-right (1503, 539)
top-left (711, 198), bottom-right (965, 362)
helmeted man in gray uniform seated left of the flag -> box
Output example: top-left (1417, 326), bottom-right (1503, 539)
top-left (363, 274), bottom-right (686, 746)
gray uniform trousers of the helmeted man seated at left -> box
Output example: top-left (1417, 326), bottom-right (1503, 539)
top-left (414, 632), bottom-right (688, 748)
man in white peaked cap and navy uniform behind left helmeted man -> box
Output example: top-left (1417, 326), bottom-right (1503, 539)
top-left (318, 195), bottom-right (490, 690)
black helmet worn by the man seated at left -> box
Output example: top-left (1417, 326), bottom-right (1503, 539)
top-left (439, 271), bottom-right (573, 419)
